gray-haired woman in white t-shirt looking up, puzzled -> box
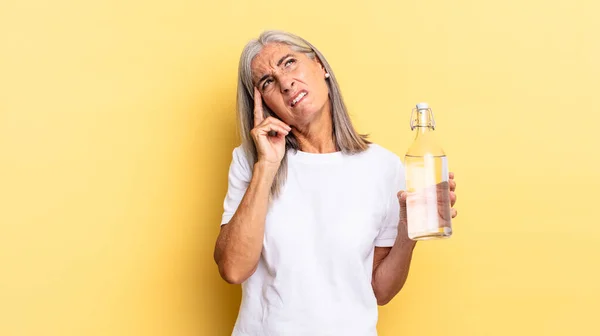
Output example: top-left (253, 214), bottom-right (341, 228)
top-left (215, 31), bottom-right (456, 336)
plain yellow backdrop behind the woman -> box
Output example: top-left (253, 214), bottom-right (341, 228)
top-left (0, 0), bottom-right (600, 336)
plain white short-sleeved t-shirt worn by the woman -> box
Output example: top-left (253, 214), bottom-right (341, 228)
top-left (222, 144), bottom-right (405, 336)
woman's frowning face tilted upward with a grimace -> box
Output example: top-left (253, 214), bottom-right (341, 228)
top-left (251, 44), bottom-right (329, 128)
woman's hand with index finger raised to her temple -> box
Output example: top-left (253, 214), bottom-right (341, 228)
top-left (250, 87), bottom-right (292, 165)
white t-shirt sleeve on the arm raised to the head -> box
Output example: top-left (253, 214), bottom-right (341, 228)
top-left (221, 146), bottom-right (252, 225)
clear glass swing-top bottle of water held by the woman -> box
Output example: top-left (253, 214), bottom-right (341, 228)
top-left (404, 103), bottom-right (452, 240)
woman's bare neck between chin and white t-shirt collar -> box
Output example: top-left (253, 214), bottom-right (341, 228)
top-left (292, 104), bottom-right (337, 153)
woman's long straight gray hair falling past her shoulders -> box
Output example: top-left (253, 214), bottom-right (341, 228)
top-left (237, 30), bottom-right (370, 198)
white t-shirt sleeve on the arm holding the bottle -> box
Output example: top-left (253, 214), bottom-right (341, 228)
top-left (375, 157), bottom-right (406, 247)
